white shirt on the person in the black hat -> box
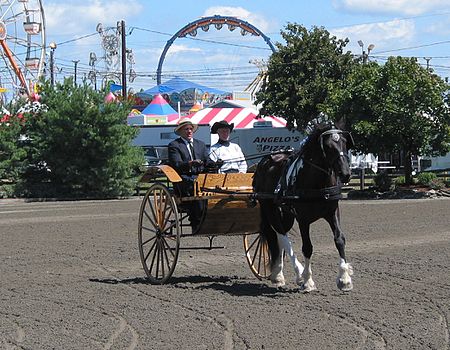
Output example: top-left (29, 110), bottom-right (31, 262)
top-left (209, 142), bottom-right (247, 174)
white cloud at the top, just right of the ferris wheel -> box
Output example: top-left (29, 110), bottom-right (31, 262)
top-left (44, 0), bottom-right (143, 36)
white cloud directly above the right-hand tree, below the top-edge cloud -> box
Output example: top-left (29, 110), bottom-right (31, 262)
top-left (332, 20), bottom-right (415, 53)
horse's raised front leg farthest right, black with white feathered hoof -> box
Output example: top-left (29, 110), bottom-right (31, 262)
top-left (327, 207), bottom-right (353, 292)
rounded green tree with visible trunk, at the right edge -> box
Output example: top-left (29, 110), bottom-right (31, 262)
top-left (330, 57), bottom-right (450, 184)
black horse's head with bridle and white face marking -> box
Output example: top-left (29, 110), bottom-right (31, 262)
top-left (311, 124), bottom-right (353, 183)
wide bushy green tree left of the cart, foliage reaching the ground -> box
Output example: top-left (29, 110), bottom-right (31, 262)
top-left (23, 79), bottom-right (143, 198)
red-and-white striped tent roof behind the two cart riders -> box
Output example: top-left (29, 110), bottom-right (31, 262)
top-left (188, 108), bottom-right (286, 129)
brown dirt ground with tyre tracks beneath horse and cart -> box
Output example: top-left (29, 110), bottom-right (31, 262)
top-left (0, 198), bottom-right (450, 350)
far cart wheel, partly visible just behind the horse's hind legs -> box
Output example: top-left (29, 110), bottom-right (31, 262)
top-left (243, 233), bottom-right (271, 280)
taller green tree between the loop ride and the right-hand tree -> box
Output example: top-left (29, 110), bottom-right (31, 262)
top-left (256, 23), bottom-right (355, 130)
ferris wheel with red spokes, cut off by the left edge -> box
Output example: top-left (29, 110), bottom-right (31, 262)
top-left (0, 0), bottom-right (45, 100)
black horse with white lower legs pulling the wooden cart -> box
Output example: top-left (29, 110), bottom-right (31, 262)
top-left (253, 122), bottom-right (353, 292)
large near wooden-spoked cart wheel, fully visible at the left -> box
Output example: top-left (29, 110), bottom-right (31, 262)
top-left (138, 183), bottom-right (181, 284)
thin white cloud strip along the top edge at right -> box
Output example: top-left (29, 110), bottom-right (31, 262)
top-left (333, 0), bottom-right (450, 16)
